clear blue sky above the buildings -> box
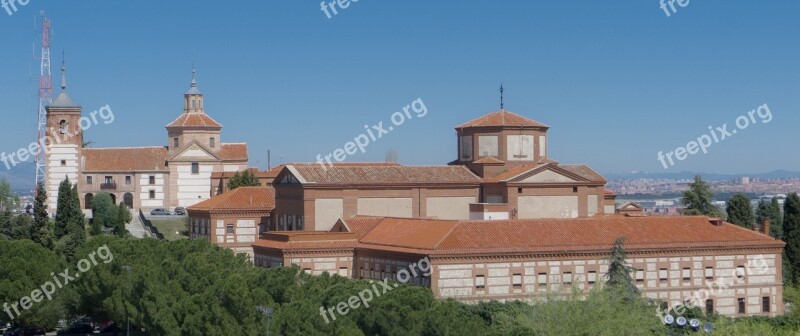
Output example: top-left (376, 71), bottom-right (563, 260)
top-left (0, 0), bottom-right (800, 173)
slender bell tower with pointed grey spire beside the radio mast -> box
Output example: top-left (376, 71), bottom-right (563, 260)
top-left (45, 63), bottom-right (83, 214)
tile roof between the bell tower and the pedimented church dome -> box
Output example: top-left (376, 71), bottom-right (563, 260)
top-left (83, 147), bottom-right (167, 172)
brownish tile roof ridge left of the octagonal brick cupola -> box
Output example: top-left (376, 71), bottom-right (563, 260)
top-left (286, 163), bottom-right (481, 186)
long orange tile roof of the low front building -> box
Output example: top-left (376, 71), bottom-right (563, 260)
top-left (347, 216), bottom-right (784, 255)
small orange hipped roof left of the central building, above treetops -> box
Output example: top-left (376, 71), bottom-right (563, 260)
top-left (187, 187), bottom-right (275, 212)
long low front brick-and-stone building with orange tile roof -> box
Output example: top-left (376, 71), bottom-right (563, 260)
top-left (253, 216), bottom-right (784, 317)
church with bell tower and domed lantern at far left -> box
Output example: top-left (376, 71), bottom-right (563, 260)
top-left (45, 69), bottom-right (247, 214)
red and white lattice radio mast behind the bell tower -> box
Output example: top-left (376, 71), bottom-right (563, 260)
top-left (34, 11), bottom-right (53, 192)
